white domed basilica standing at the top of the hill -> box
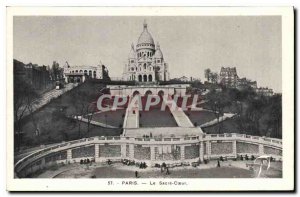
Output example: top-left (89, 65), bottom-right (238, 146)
top-left (123, 22), bottom-right (169, 82)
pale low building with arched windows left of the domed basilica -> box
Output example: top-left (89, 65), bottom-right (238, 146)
top-left (64, 62), bottom-right (109, 83)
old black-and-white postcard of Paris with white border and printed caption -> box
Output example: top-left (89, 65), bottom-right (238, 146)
top-left (7, 7), bottom-right (295, 191)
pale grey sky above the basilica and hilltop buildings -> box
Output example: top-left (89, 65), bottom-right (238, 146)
top-left (13, 16), bottom-right (282, 92)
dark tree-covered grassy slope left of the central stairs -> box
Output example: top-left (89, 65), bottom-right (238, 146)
top-left (16, 81), bottom-right (122, 149)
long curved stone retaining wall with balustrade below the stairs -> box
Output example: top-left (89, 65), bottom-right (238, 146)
top-left (15, 133), bottom-right (282, 177)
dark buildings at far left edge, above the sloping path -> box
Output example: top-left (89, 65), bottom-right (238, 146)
top-left (14, 60), bottom-right (52, 91)
